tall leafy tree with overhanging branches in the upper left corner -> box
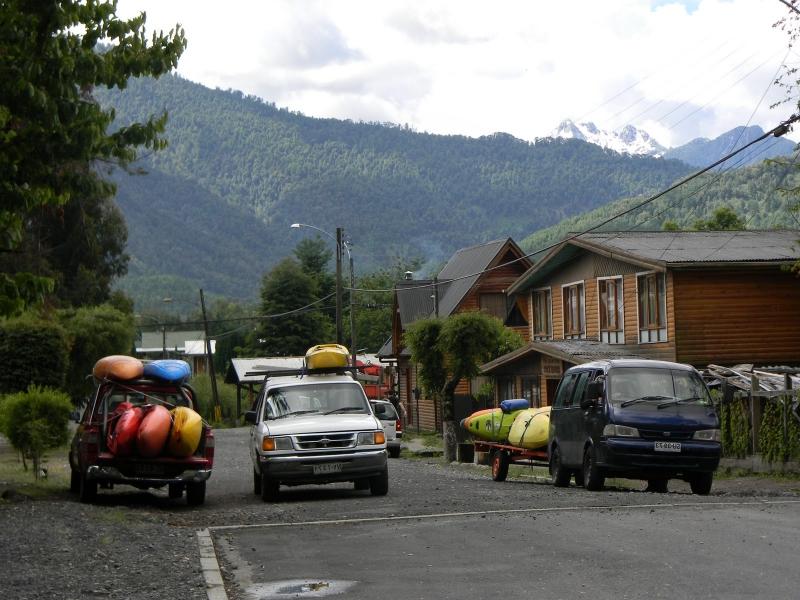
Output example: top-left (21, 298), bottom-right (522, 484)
top-left (0, 0), bottom-right (186, 314)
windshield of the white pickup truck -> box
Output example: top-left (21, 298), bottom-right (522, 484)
top-left (264, 382), bottom-right (369, 419)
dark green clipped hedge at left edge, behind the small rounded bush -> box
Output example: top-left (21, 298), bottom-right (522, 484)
top-left (0, 313), bottom-right (69, 393)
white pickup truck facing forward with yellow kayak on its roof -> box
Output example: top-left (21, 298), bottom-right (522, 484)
top-left (245, 368), bottom-right (389, 502)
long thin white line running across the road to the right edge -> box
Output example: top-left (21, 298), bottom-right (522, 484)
top-left (205, 500), bottom-right (800, 535)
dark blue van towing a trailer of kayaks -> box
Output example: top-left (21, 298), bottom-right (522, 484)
top-left (548, 359), bottom-right (722, 495)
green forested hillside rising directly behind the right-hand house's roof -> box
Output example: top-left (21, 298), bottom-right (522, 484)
top-left (520, 159), bottom-right (800, 258)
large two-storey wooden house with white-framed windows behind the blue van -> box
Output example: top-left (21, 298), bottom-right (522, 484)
top-left (483, 231), bottom-right (800, 406)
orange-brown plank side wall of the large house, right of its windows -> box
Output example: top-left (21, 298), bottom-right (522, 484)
top-left (672, 268), bottom-right (800, 366)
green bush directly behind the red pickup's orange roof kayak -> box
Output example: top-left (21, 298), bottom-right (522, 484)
top-left (59, 304), bottom-right (135, 403)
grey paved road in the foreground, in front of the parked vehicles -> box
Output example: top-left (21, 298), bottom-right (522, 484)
top-left (202, 429), bottom-right (800, 600)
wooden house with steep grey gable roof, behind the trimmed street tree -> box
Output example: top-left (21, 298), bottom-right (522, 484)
top-left (388, 238), bottom-right (532, 431)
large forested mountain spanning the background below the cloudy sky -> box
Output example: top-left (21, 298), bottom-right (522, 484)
top-left (97, 76), bottom-right (689, 308)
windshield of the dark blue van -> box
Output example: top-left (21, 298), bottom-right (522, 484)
top-left (607, 367), bottom-right (711, 408)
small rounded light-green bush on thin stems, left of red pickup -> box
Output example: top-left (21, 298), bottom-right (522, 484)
top-left (0, 385), bottom-right (72, 479)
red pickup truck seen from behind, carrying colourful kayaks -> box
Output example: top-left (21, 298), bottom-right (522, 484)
top-left (69, 379), bottom-right (214, 505)
